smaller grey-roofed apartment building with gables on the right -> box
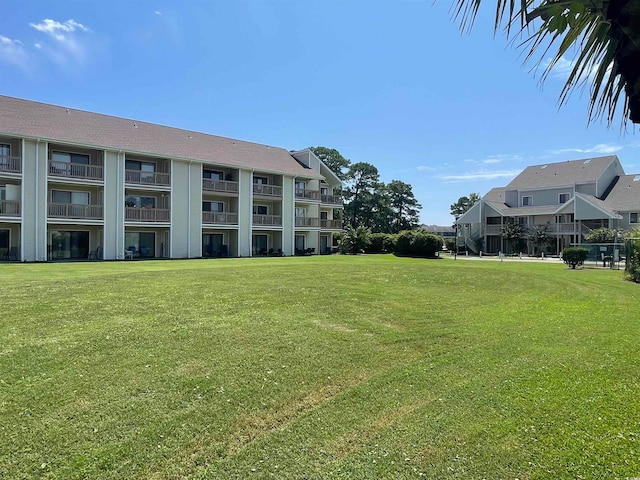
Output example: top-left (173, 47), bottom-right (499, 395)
top-left (457, 155), bottom-right (640, 253)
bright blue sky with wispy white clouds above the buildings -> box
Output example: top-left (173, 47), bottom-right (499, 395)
top-left (0, 0), bottom-right (640, 225)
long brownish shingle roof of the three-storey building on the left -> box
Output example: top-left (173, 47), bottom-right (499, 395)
top-left (0, 95), bottom-right (322, 178)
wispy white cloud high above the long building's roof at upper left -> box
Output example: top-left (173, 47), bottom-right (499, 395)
top-left (29, 18), bottom-right (91, 64)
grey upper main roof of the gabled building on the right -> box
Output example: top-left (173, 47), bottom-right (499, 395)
top-left (506, 155), bottom-right (619, 190)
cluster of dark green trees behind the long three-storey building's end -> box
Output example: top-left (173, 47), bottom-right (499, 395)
top-left (309, 147), bottom-right (422, 234)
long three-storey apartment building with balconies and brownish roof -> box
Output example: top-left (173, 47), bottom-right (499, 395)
top-left (0, 96), bottom-right (343, 261)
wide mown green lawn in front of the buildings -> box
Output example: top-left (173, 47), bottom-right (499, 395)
top-left (0, 256), bottom-right (640, 479)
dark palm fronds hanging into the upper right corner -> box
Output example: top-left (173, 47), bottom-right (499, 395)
top-left (454, 0), bottom-right (640, 125)
